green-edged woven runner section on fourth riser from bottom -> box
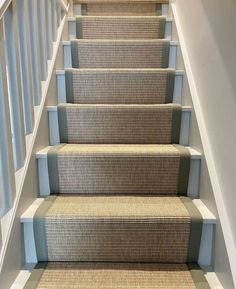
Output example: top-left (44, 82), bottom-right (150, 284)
top-left (66, 69), bottom-right (175, 104)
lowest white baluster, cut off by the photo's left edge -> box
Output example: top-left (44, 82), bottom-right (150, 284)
top-left (0, 19), bottom-right (15, 212)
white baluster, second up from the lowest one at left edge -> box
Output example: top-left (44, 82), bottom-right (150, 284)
top-left (4, 2), bottom-right (26, 170)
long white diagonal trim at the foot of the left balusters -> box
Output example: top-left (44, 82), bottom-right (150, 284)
top-left (0, 16), bottom-right (66, 272)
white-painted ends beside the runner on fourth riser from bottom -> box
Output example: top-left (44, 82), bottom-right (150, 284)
top-left (56, 69), bottom-right (184, 104)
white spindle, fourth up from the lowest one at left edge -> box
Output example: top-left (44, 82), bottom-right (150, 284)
top-left (27, 0), bottom-right (42, 105)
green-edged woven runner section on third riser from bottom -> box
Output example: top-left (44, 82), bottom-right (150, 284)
top-left (58, 104), bottom-right (182, 144)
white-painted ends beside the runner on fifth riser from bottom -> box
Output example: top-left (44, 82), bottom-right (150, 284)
top-left (62, 41), bottom-right (178, 68)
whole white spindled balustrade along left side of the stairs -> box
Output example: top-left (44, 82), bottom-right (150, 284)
top-left (0, 0), bottom-right (69, 251)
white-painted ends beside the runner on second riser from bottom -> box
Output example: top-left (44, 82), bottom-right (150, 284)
top-left (36, 147), bottom-right (201, 199)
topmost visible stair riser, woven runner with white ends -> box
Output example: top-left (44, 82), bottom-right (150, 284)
top-left (73, 3), bottom-right (169, 16)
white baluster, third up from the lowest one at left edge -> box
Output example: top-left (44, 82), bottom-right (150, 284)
top-left (15, 0), bottom-right (34, 134)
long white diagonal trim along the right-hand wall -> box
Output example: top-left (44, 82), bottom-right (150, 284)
top-left (171, 2), bottom-right (236, 285)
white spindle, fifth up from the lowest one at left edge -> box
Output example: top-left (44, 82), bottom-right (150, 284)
top-left (36, 0), bottom-right (48, 81)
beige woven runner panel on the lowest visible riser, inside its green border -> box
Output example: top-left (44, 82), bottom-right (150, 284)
top-left (36, 220), bottom-right (193, 263)
